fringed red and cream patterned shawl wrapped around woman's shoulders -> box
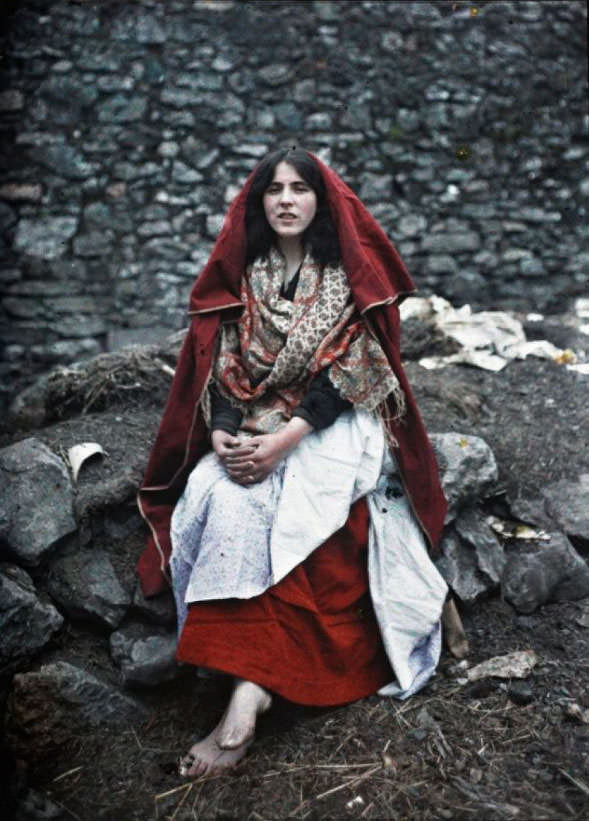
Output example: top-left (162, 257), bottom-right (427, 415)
top-left (205, 248), bottom-right (405, 433)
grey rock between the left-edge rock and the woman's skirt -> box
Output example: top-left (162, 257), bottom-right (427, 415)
top-left (47, 549), bottom-right (131, 628)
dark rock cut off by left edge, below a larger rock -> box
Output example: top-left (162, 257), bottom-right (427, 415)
top-left (0, 562), bottom-right (63, 676)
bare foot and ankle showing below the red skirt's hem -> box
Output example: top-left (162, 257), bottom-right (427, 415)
top-left (178, 679), bottom-right (272, 776)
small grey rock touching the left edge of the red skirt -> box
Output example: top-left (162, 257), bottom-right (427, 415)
top-left (110, 623), bottom-right (179, 686)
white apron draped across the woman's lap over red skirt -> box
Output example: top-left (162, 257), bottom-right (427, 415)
top-left (170, 410), bottom-right (447, 698)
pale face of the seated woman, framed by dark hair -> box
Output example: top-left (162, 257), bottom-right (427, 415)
top-left (264, 162), bottom-right (317, 239)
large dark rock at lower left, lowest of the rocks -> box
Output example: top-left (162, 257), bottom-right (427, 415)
top-left (6, 661), bottom-right (149, 761)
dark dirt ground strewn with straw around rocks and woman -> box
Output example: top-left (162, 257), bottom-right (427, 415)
top-left (4, 310), bottom-right (589, 821)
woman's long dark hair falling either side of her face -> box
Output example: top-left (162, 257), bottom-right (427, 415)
top-left (245, 147), bottom-right (341, 267)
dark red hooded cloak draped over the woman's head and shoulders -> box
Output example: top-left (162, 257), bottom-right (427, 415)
top-left (138, 154), bottom-right (446, 595)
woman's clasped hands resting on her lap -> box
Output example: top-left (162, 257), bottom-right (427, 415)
top-left (211, 430), bottom-right (289, 485)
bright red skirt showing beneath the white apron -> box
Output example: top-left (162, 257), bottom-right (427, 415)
top-left (177, 499), bottom-right (395, 706)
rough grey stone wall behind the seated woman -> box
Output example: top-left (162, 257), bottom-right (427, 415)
top-left (0, 0), bottom-right (589, 398)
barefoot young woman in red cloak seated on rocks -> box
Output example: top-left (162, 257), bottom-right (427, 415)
top-left (138, 149), bottom-right (447, 776)
